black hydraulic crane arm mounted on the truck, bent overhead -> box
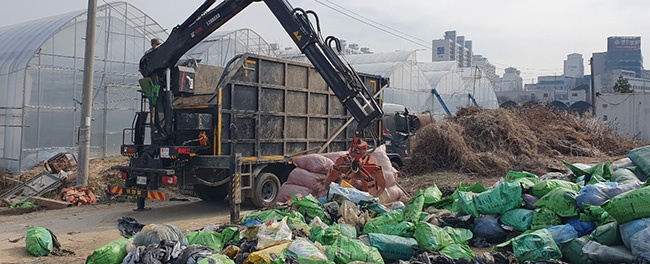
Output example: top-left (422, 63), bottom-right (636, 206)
top-left (140, 0), bottom-right (383, 140)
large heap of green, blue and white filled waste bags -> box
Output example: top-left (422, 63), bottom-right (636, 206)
top-left (54, 146), bottom-right (650, 264)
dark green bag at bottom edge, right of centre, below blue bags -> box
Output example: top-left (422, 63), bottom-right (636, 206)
top-left (512, 229), bottom-right (562, 262)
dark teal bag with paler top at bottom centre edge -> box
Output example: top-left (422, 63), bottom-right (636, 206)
top-left (368, 233), bottom-right (418, 260)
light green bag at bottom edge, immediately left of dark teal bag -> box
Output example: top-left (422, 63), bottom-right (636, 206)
top-left (327, 236), bottom-right (384, 264)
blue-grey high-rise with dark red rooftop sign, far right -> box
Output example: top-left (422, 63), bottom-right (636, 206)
top-left (605, 36), bottom-right (643, 78)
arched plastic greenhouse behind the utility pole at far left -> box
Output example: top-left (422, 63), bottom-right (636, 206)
top-left (0, 2), bottom-right (167, 173)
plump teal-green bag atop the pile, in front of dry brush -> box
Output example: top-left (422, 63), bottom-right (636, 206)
top-left (474, 181), bottom-right (523, 215)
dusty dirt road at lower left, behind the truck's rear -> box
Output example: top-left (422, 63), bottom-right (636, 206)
top-left (0, 198), bottom-right (253, 263)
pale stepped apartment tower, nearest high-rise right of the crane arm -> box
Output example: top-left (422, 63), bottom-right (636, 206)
top-left (431, 31), bottom-right (474, 68)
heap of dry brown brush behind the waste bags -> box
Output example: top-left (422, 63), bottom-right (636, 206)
top-left (406, 105), bottom-right (635, 177)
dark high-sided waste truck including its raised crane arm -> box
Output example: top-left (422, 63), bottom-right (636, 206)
top-left (109, 0), bottom-right (387, 216)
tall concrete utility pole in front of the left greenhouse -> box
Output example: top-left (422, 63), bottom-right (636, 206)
top-left (77, 0), bottom-right (97, 186)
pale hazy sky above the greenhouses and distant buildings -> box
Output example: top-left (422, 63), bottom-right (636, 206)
top-left (0, 0), bottom-right (650, 83)
